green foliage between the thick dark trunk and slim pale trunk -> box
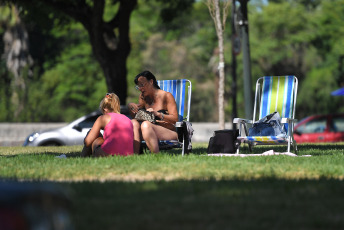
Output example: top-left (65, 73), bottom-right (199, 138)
top-left (127, 1), bottom-right (217, 121)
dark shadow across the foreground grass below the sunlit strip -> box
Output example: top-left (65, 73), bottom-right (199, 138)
top-left (53, 178), bottom-right (344, 230)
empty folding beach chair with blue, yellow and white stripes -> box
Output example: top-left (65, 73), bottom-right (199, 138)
top-left (233, 76), bottom-right (298, 154)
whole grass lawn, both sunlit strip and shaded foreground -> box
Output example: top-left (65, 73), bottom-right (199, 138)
top-left (0, 143), bottom-right (344, 229)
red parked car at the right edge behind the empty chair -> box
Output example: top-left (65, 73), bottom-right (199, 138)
top-left (294, 114), bottom-right (344, 143)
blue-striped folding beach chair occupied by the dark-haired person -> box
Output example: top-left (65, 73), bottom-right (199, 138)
top-left (142, 79), bottom-right (192, 156)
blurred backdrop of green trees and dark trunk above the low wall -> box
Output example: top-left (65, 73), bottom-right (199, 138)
top-left (0, 0), bottom-right (344, 135)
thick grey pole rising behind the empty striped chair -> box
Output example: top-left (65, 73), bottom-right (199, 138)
top-left (238, 0), bottom-right (253, 119)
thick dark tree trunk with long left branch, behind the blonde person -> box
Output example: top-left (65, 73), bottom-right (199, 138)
top-left (34, 0), bottom-right (137, 105)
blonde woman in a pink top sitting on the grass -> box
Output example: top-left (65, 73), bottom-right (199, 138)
top-left (84, 93), bottom-right (134, 157)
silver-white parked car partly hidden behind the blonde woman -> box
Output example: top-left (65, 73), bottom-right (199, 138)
top-left (23, 106), bottom-right (129, 146)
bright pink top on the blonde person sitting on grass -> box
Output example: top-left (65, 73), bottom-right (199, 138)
top-left (101, 113), bottom-right (134, 156)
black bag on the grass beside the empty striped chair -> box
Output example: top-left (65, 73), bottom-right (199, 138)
top-left (207, 129), bottom-right (239, 153)
